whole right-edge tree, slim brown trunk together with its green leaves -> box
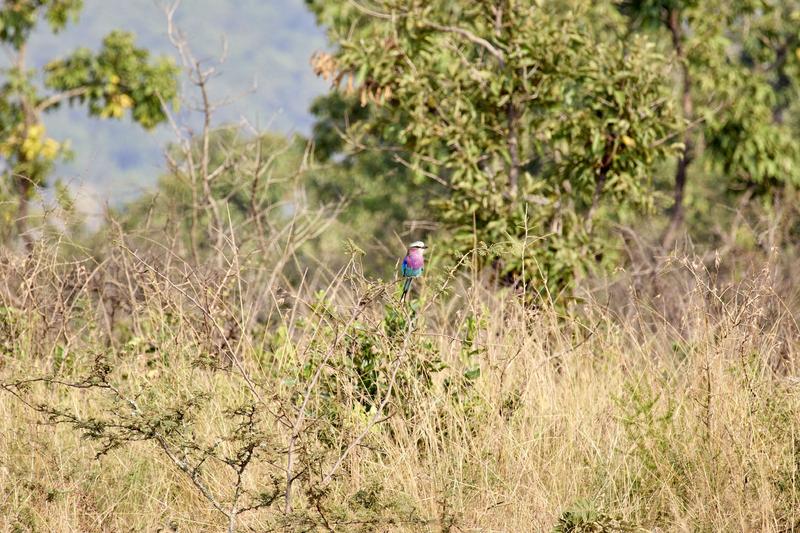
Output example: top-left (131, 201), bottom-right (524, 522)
top-left (618, 0), bottom-right (800, 247)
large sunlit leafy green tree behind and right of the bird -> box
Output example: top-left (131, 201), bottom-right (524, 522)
top-left (309, 0), bottom-right (675, 294)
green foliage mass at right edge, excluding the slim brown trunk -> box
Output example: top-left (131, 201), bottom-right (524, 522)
top-left (698, 2), bottom-right (800, 194)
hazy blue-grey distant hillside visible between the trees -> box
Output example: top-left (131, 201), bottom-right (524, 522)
top-left (21, 0), bottom-right (326, 204)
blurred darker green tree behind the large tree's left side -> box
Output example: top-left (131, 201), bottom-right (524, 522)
top-left (306, 92), bottom-right (446, 274)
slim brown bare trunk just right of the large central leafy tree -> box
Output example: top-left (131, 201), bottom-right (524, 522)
top-left (661, 9), bottom-right (694, 249)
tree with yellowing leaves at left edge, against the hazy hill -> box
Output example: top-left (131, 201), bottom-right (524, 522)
top-left (0, 0), bottom-right (177, 243)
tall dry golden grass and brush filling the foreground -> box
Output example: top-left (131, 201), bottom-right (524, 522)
top-left (0, 229), bottom-right (800, 531)
